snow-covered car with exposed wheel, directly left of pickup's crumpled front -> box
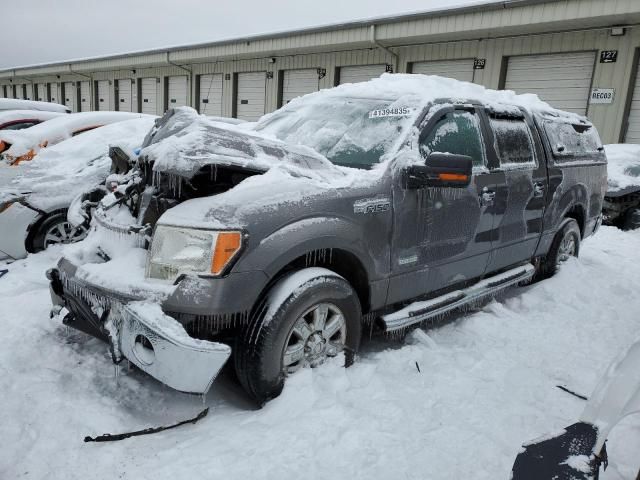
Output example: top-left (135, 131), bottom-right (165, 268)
top-left (0, 115), bottom-right (156, 259)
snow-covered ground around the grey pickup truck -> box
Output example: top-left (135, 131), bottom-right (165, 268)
top-left (0, 228), bottom-right (640, 480)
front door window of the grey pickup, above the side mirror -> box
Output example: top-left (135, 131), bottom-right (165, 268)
top-left (420, 112), bottom-right (486, 167)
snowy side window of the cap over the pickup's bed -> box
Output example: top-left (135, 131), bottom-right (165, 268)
top-left (544, 120), bottom-right (603, 162)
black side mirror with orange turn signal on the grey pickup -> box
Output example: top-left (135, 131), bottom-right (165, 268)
top-left (405, 153), bottom-right (473, 189)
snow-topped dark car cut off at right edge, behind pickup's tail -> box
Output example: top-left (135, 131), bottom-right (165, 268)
top-left (602, 144), bottom-right (640, 230)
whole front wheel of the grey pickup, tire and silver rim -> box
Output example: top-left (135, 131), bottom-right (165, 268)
top-left (235, 268), bottom-right (361, 405)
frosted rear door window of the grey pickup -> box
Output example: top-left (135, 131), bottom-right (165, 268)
top-left (489, 118), bottom-right (536, 168)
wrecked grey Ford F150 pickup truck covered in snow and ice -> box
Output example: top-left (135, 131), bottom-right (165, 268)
top-left (48, 75), bottom-right (606, 404)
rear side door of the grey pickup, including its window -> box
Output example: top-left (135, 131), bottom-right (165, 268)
top-left (487, 111), bottom-right (547, 272)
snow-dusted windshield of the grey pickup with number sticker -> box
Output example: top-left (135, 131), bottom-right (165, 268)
top-left (256, 97), bottom-right (418, 169)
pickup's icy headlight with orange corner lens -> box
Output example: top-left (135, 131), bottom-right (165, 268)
top-left (146, 225), bottom-right (242, 280)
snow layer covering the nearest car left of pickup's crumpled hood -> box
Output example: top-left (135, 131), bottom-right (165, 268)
top-left (0, 116), bottom-right (154, 209)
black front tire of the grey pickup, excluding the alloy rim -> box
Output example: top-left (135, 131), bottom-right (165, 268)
top-left (234, 268), bottom-right (362, 406)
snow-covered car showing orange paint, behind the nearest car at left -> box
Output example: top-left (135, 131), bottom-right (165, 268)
top-left (0, 112), bottom-right (144, 165)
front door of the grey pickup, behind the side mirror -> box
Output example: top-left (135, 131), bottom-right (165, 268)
top-left (387, 106), bottom-right (496, 303)
